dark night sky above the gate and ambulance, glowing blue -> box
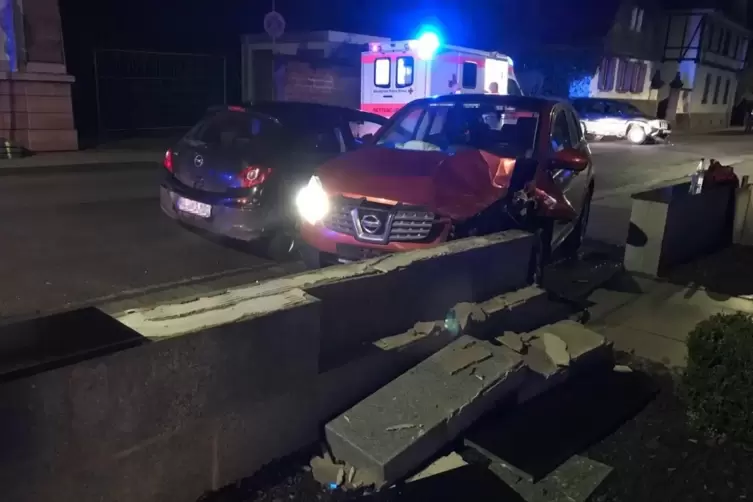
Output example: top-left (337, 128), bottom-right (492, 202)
top-left (60, 0), bottom-right (531, 51)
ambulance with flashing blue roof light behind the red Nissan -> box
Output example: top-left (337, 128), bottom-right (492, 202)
top-left (361, 32), bottom-right (522, 118)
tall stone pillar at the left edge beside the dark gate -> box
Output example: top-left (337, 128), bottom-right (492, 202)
top-left (0, 0), bottom-right (78, 152)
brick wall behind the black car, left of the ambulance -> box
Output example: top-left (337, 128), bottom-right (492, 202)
top-left (277, 60), bottom-right (361, 108)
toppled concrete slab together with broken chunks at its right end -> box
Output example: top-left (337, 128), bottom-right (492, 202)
top-left (326, 320), bottom-right (620, 487)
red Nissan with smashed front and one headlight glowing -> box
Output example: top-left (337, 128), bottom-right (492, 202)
top-left (296, 94), bottom-right (594, 275)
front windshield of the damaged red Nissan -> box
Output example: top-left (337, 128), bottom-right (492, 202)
top-left (376, 102), bottom-right (539, 157)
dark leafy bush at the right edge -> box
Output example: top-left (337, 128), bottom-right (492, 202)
top-left (682, 313), bottom-right (753, 443)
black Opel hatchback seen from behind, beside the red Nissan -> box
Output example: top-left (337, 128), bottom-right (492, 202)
top-left (160, 102), bottom-right (386, 254)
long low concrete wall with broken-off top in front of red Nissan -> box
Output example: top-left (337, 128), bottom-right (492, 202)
top-left (0, 232), bottom-right (552, 502)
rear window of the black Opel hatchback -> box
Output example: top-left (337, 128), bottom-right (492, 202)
top-left (186, 111), bottom-right (281, 148)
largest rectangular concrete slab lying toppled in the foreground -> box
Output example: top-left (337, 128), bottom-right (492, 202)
top-left (325, 336), bottom-right (525, 484)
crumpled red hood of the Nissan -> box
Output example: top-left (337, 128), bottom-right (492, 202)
top-left (318, 147), bottom-right (515, 220)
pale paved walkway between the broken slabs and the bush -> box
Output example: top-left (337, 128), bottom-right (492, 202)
top-left (588, 246), bottom-right (753, 369)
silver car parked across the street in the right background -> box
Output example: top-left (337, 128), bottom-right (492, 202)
top-left (572, 98), bottom-right (672, 145)
